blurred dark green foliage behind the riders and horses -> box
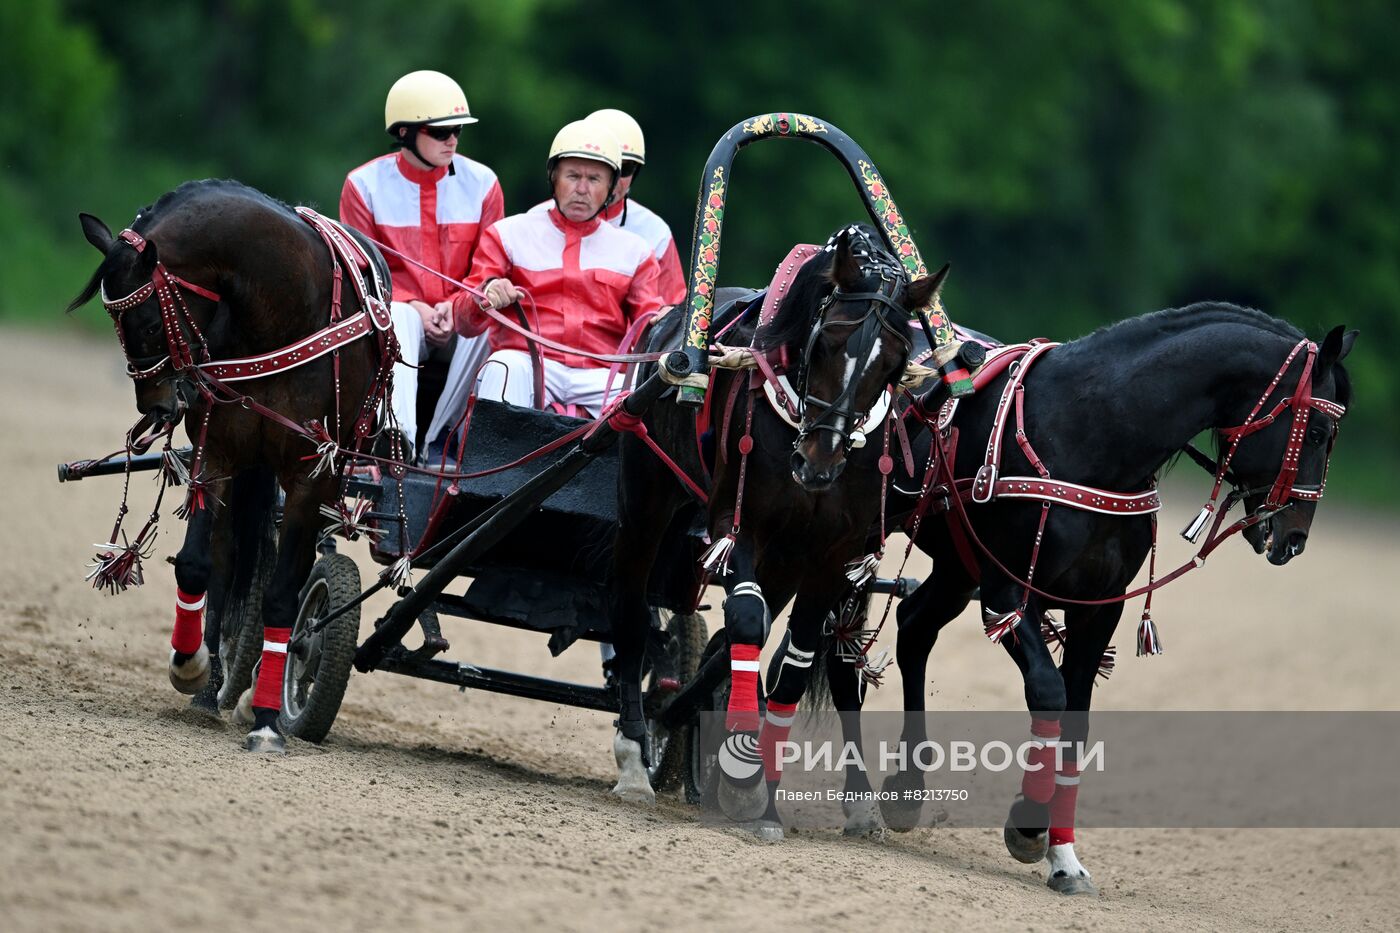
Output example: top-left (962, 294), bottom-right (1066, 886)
top-left (0, 0), bottom-right (1400, 500)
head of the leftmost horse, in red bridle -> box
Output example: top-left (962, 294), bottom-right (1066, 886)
top-left (69, 214), bottom-right (218, 422)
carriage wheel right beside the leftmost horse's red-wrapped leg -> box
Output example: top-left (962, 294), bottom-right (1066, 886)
top-left (277, 553), bottom-right (360, 742)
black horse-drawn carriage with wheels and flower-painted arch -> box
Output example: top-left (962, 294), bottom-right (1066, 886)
top-left (59, 113), bottom-right (956, 800)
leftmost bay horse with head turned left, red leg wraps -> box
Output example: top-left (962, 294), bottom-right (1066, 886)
top-left (69, 179), bottom-right (396, 754)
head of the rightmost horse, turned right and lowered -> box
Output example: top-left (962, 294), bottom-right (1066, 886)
top-left (1219, 326), bottom-right (1357, 566)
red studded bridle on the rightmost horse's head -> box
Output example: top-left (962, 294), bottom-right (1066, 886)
top-left (1182, 332), bottom-right (1347, 542)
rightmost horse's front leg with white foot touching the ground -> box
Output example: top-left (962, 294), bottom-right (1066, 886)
top-left (1046, 602), bottom-right (1123, 894)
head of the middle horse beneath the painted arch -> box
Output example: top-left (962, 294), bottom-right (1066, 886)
top-left (774, 226), bottom-right (948, 492)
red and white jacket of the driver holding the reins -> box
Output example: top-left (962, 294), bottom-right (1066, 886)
top-left (452, 207), bottom-right (665, 368)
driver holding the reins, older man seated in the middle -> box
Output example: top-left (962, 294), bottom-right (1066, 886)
top-left (454, 120), bottom-right (665, 413)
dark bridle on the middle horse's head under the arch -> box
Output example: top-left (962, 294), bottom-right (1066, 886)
top-left (794, 228), bottom-right (913, 451)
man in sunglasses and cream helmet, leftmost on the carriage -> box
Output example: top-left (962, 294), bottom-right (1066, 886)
top-left (340, 71), bottom-right (505, 452)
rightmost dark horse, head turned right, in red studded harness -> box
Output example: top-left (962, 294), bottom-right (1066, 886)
top-left (826, 303), bottom-right (1357, 894)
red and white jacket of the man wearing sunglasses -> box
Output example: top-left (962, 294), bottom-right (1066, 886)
top-left (340, 150), bottom-right (505, 304)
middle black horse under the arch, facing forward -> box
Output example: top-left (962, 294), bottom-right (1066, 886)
top-left (612, 226), bottom-right (946, 835)
